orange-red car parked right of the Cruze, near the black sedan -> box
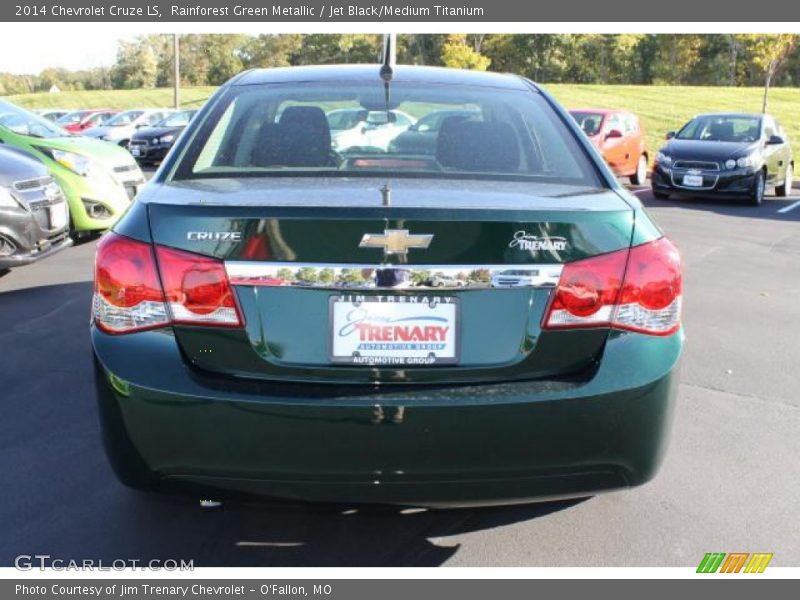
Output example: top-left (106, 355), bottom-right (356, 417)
top-left (569, 108), bottom-right (647, 185)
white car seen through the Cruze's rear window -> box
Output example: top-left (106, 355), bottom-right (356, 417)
top-left (326, 108), bottom-right (416, 152)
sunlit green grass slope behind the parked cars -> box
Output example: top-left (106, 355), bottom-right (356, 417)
top-left (7, 84), bottom-right (800, 155)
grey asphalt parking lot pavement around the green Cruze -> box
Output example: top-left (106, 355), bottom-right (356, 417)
top-left (0, 177), bottom-right (800, 566)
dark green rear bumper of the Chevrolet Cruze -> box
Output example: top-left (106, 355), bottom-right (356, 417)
top-left (92, 329), bottom-right (683, 506)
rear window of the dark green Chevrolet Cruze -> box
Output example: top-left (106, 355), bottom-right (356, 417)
top-left (173, 81), bottom-right (600, 187)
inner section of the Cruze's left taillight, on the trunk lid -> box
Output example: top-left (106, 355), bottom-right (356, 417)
top-left (156, 246), bottom-right (242, 327)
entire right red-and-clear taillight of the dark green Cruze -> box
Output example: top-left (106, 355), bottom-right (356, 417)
top-left (544, 238), bottom-right (682, 335)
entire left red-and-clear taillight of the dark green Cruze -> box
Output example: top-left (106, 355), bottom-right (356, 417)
top-left (93, 233), bottom-right (242, 333)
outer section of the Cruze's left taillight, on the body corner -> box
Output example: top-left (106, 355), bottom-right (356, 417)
top-left (93, 233), bottom-right (169, 333)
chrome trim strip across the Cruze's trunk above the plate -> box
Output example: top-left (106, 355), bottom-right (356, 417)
top-left (225, 261), bottom-right (564, 291)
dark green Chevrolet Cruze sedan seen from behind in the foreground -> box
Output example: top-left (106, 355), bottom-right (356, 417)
top-left (91, 65), bottom-right (683, 506)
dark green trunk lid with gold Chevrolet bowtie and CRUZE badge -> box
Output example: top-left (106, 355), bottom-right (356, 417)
top-left (147, 178), bottom-right (634, 384)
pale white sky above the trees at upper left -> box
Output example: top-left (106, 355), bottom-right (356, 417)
top-left (0, 30), bottom-right (132, 75)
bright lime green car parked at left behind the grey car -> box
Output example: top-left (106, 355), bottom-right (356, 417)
top-left (0, 100), bottom-right (145, 235)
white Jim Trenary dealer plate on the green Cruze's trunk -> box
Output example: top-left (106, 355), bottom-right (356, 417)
top-left (330, 295), bottom-right (459, 367)
